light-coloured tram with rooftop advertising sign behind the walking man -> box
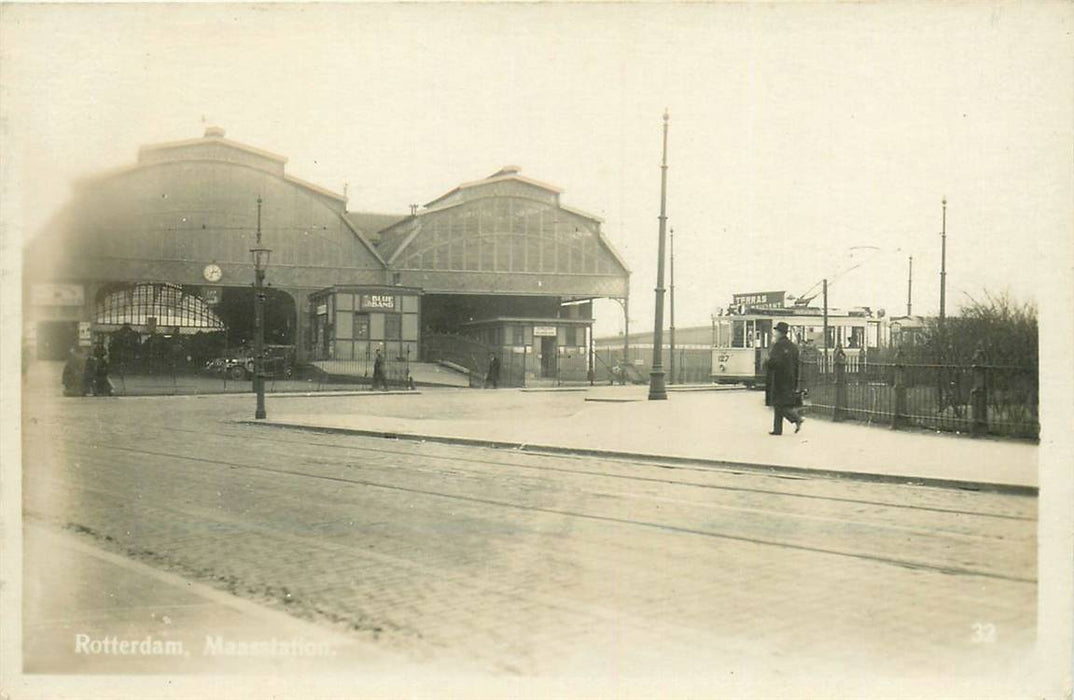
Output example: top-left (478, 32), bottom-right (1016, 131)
top-left (712, 308), bottom-right (884, 388)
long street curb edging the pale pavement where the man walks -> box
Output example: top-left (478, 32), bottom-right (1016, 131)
top-left (236, 419), bottom-right (1039, 496)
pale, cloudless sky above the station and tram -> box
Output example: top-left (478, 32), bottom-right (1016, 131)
top-left (0, 2), bottom-right (1074, 335)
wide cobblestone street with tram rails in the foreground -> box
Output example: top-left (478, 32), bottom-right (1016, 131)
top-left (24, 396), bottom-right (1036, 677)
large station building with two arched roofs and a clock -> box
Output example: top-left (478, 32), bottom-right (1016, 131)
top-left (24, 128), bottom-right (629, 376)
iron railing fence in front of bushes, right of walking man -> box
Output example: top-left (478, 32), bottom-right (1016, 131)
top-left (800, 358), bottom-right (1040, 439)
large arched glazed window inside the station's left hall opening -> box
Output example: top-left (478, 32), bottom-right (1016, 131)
top-left (93, 283), bottom-right (224, 333)
